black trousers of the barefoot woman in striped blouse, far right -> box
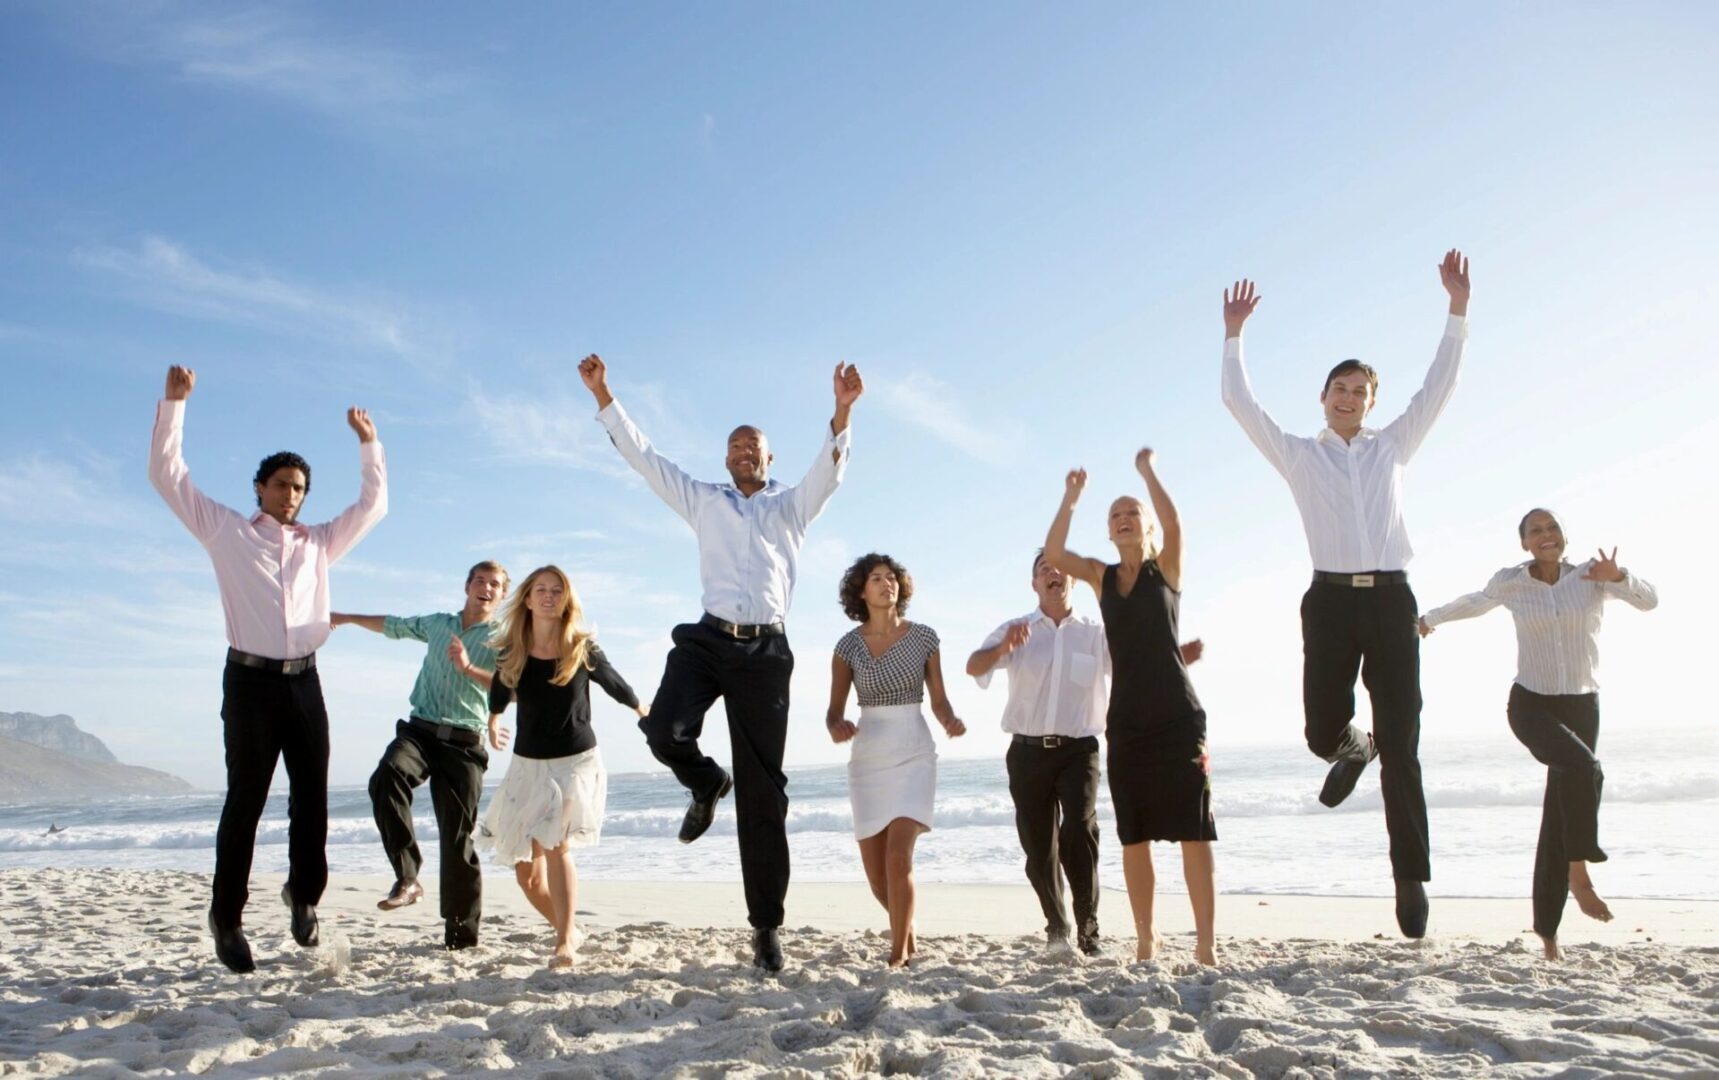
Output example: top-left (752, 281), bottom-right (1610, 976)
top-left (1508, 683), bottom-right (1606, 937)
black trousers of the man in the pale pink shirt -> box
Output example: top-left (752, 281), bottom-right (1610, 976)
top-left (210, 662), bottom-right (328, 929)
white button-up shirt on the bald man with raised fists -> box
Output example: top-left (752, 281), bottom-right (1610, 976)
top-left (596, 401), bottom-right (853, 626)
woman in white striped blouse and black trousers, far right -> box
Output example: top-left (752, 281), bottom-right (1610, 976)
top-left (1420, 509), bottom-right (1659, 960)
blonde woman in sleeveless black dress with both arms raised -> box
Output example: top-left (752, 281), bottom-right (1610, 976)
top-left (1045, 451), bottom-right (1217, 965)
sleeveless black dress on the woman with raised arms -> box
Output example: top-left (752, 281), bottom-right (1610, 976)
top-left (1098, 559), bottom-right (1217, 844)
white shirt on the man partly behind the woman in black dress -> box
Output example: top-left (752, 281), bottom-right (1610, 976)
top-left (975, 609), bottom-right (1110, 739)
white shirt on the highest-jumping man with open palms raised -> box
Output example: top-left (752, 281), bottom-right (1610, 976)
top-left (1224, 315), bottom-right (1468, 574)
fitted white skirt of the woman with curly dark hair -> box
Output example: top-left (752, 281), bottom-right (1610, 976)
top-left (847, 705), bottom-right (937, 839)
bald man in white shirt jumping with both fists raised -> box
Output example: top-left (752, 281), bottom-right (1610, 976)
top-left (579, 356), bottom-right (865, 972)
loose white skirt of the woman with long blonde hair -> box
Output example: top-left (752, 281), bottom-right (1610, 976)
top-left (478, 746), bottom-right (609, 863)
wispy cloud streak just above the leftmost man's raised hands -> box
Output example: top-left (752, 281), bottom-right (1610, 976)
top-left (74, 236), bottom-right (413, 354)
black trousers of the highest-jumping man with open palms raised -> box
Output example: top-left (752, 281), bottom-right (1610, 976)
top-left (1301, 581), bottom-right (1432, 881)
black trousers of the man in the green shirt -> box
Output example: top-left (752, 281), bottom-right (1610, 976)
top-left (370, 721), bottom-right (490, 930)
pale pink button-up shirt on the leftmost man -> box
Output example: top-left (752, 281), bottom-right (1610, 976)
top-left (150, 401), bottom-right (388, 660)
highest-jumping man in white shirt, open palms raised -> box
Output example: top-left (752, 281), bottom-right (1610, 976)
top-left (1224, 249), bottom-right (1470, 937)
